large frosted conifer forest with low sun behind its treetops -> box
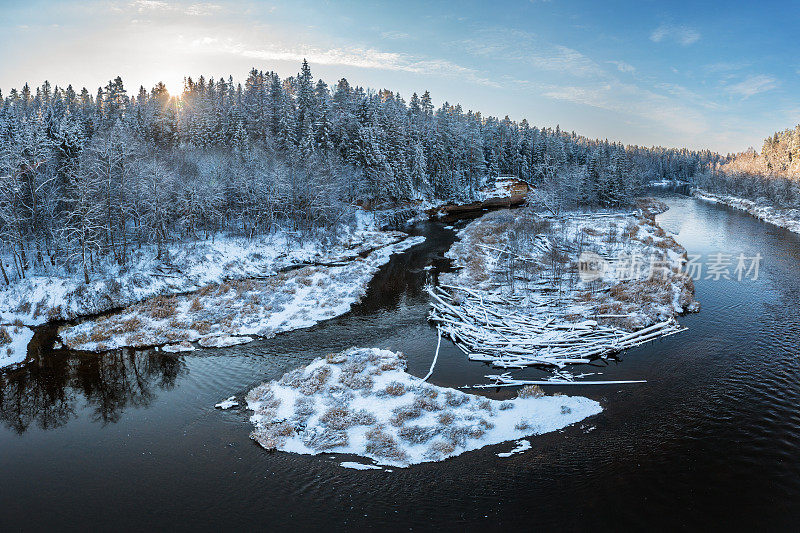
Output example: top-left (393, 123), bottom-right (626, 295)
top-left (0, 62), bottom-right (718, 283)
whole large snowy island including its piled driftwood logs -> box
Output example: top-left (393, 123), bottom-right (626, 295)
top-left (429, 201), bottom-right (699, 378)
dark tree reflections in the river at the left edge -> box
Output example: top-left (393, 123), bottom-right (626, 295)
top-left (0, 339), bottom-right (187, 434)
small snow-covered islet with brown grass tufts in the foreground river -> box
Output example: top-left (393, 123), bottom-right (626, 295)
top-left (247, 348), bottom-right (602, 467)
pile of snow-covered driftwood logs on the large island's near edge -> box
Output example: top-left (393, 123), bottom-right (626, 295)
top-left (428, 285), bottom-right (685, 370)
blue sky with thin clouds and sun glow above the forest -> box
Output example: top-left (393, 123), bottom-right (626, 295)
top-left (0, 0), bottom-right (800, 152)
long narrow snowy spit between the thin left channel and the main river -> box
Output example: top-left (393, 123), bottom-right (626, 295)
top-left (61, 232), bottom-right (425, 351)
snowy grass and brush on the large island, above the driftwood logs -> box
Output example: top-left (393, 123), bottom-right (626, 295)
top-left (439, 203), bottom-right (697, 330)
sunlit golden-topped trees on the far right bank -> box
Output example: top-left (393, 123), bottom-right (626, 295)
top-left (695, 125), bottom-right (800, 208)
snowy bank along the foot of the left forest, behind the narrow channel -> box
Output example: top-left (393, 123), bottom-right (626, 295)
top-left (0, 218), bottom-right (405, 325)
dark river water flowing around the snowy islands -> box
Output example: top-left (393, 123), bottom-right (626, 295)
top-left (0, 196), bottom-right (800, 531)
